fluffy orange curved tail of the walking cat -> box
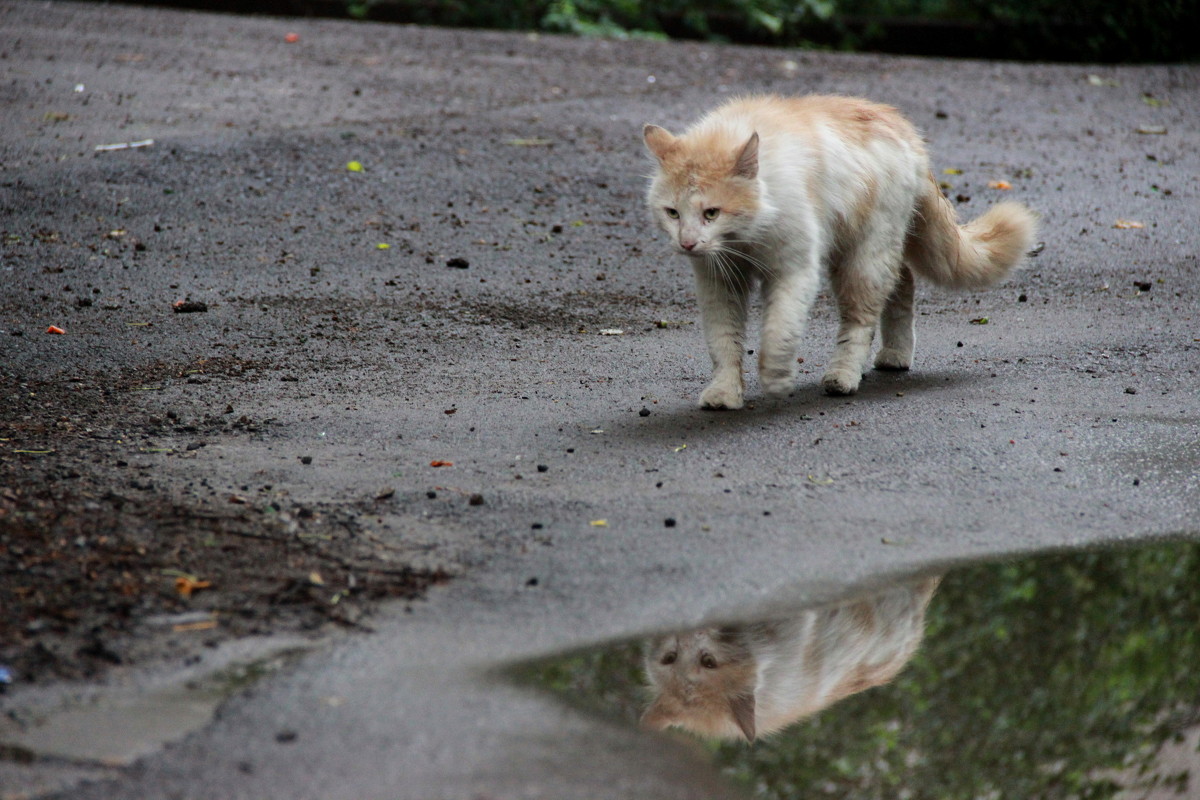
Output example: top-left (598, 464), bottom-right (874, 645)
top-left (905, 175), bottom-right (1038, 289)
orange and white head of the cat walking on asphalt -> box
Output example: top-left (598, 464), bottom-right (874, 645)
top-left (642, 125), bottom-right (761, 257)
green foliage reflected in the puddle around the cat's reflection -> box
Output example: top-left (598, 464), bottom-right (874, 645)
top-left (530, 542), bottom-right (1200, 800)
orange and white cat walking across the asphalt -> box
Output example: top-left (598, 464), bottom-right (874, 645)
top-left (642, 95), bottom-right (1037, 409)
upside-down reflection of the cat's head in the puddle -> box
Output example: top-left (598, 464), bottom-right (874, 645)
top-left (642, 628), bottom-right (757, 741)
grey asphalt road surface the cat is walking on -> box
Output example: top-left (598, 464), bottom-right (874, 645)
top-left (0, 1), bottom-right (1200, 800)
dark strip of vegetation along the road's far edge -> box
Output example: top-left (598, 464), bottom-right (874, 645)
top-left (126, 0), bottom-right (1200, 62)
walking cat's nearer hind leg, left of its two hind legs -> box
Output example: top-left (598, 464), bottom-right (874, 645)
top-left (821, 224), bottom-right (904, 395)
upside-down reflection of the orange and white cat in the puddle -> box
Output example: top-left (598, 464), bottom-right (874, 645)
top-left (642, 578), bottom-right (938, 742)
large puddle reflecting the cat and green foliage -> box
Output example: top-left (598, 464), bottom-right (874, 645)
top-left (515, 542), bottom-right (1200, 800)
